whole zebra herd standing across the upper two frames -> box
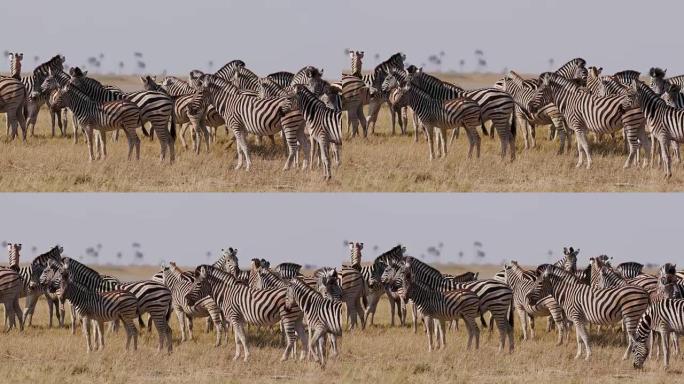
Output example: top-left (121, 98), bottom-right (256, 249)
top-left (8, 51), bottom-right (684, 178)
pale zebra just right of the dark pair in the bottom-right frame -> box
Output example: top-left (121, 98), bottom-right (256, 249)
top-left (504, 261), bottom-right (565, 345)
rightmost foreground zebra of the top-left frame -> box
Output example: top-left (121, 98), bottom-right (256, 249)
top-left (295, 86), bottom-right (342, 179)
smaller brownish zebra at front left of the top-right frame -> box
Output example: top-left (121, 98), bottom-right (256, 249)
top-left (397, 85), bottom-right (482, 160)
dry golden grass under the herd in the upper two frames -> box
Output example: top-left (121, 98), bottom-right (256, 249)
top-left (0, 75), bottom-right (684, 192)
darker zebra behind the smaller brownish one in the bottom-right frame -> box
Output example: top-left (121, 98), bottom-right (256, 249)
top-left (395, 256), bottom-right (514, 352)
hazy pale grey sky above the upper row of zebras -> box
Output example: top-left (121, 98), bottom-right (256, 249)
top-left (0, 0), bottom-right (684, 78)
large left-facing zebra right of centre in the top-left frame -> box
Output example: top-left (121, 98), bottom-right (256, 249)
top-left (184, 71), bottom-right (309, 169)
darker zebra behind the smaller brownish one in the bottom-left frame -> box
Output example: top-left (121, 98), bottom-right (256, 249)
top-left (39, 257), bottom-right (173, 353)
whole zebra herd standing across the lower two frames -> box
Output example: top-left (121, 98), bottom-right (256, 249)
top-left (0, 242), bottom-right (684, 368)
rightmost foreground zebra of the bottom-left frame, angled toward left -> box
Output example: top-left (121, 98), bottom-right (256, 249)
top-left (285, 277), bottom-right (342, 365)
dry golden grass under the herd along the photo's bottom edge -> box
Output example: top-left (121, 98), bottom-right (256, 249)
top-left (0, 266), bottom-right (684, 384)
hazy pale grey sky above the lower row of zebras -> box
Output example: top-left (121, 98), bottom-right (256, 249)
top-left (0, 193), bottom-right (684, 267)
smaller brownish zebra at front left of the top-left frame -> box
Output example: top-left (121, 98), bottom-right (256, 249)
top-left (41, 71), bottom-right (147, 161)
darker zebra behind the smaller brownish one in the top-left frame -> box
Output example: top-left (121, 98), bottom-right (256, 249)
top-left (69, 67), bottom-right (176, 163)
